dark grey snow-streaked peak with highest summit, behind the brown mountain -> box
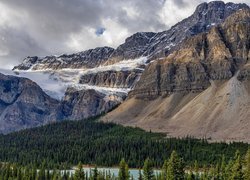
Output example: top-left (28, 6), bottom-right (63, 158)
top-left (106, 1), bottom-right (249, 63)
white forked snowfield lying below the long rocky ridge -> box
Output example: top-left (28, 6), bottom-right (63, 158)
top-left (0, 57), bottom-right (148, 100)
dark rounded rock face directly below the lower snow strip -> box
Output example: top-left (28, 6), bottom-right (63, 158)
top-left (60, 88), bottom-right (123, 120)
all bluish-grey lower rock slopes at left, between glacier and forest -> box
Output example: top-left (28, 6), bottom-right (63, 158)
top-left (0, 74), bottom-right (123, 133)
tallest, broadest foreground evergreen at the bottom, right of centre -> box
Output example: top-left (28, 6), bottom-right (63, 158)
top-left (167, 151), bottom-right (185, 180)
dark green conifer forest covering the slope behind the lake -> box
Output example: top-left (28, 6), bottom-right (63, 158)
top-left (0, 119), bottom-right (249, 169)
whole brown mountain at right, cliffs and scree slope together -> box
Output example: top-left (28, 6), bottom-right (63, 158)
top-left (103, 9), bottom-right (250, 142)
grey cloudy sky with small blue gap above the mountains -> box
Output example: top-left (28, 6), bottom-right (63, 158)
top-left (0, 0), bottom-right (250, 68)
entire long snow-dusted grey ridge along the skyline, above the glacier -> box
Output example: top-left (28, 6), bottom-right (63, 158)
top-left (14, 1), bottom-right (249, 70)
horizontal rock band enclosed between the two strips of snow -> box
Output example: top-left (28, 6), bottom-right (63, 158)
top-left (79, 69), bottom-right (142, 88)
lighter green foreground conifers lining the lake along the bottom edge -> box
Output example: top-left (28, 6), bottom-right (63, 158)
top-left (0, 150), bottom-right (250, 180)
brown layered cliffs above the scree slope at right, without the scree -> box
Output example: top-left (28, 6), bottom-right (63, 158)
top-left (130, 10), bottom-right (250, 98)
